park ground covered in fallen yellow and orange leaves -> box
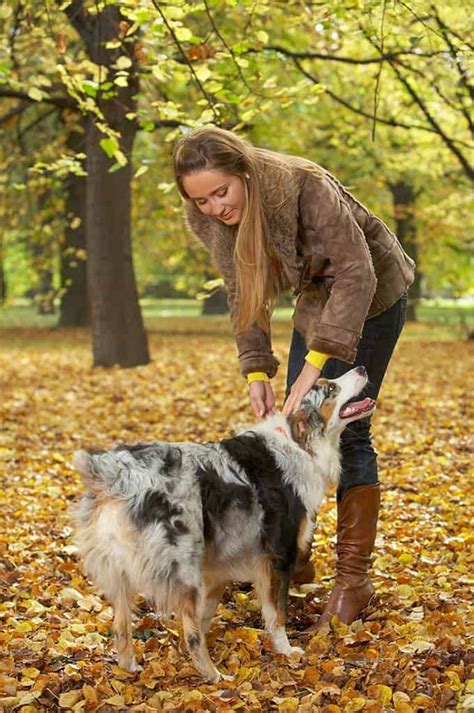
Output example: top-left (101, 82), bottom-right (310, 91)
top-left (0, 322), bottom-right (474, 713)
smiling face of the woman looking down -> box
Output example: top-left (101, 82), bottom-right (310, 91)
top-left (183, 168), bottom-right (247, 225)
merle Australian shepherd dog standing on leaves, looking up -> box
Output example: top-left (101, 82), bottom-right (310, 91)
top-left (74, 367), bottom-right (374, 681)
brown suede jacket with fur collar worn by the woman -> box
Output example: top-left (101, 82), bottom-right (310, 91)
top-left (186, 156), bottom-right (415, 376)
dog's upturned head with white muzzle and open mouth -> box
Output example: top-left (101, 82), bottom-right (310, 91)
top-left (288, 366), bottom-right (375, 450)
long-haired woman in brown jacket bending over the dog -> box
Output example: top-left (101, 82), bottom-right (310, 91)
top-left (174, 127), bottom-right (414, 624)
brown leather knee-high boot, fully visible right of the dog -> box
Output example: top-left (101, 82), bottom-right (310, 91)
top-left (317, 483), bottom-right (380, 627)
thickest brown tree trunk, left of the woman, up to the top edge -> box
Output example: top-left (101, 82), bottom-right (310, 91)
top-left (84, 5), bottom-right (150, 367)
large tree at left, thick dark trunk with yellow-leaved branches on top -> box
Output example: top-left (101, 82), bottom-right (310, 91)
top-left (0, 1), bottom-right (149, 366)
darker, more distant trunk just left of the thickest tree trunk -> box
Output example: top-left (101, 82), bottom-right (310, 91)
top-left (58, 122), bottom-right (90, 327)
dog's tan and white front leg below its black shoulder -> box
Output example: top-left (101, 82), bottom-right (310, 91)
top-left (255, 557), bottom-right (303, 656)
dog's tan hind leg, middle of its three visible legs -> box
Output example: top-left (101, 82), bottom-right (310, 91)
top-left (181, 589), bottom-right (228, 683)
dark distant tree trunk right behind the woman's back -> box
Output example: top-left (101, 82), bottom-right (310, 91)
top-left (390, 181), bottom-right (421, 322)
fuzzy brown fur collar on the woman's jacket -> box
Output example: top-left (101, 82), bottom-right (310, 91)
top-left (185, 154), bottom-right (314, 289)
